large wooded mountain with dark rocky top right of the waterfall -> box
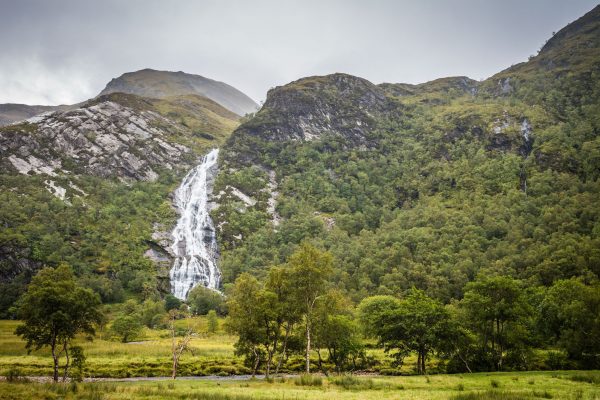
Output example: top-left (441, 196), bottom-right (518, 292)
top-left (213, 7), bottom-right (600, 302)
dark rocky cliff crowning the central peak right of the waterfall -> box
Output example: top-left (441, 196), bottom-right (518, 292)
top-left (227, 74), bottom-right (396, 152)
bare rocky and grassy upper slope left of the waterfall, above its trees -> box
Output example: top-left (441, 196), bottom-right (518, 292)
top-left (0, 93), bottom-right (238, 181)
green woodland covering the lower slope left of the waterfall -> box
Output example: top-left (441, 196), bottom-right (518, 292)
top-left (0, 173), bottom-right (179, 318)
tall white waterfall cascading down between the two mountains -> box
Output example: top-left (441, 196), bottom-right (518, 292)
top-left (169, 149), bottom-right (221, 300)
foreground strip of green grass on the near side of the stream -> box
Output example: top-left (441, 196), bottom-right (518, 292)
top-left (0, 371), bottom-right (600, 400)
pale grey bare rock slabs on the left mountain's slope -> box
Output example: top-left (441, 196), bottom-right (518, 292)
top-left (0, 101), bottom-right (191, 181)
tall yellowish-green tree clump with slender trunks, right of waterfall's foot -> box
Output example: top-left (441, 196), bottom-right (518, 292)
top-left (227, 243), bottom-right (332, 376)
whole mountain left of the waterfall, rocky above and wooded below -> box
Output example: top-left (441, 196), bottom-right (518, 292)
top-left (0, 81), bottom-right (247, 316)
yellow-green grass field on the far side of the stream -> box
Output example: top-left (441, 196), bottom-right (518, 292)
top-left (0, 317), bottom-right (408, 378)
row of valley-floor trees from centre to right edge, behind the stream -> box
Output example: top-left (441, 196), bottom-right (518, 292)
top-left (227, 242), bottom-right (600, 375)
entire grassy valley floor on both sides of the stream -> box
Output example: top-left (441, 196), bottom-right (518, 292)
top-left (0, 317), bottom-right (600, 400)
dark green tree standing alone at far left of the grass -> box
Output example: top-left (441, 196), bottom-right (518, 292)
top-left (15, 264), bottom-right (103, 382)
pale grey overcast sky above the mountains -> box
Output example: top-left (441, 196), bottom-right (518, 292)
top-left (0, 0), bottom-right (598, 104)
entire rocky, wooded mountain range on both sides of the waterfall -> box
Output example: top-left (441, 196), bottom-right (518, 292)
top-left (0, 7), bottom-right (600, 316)
